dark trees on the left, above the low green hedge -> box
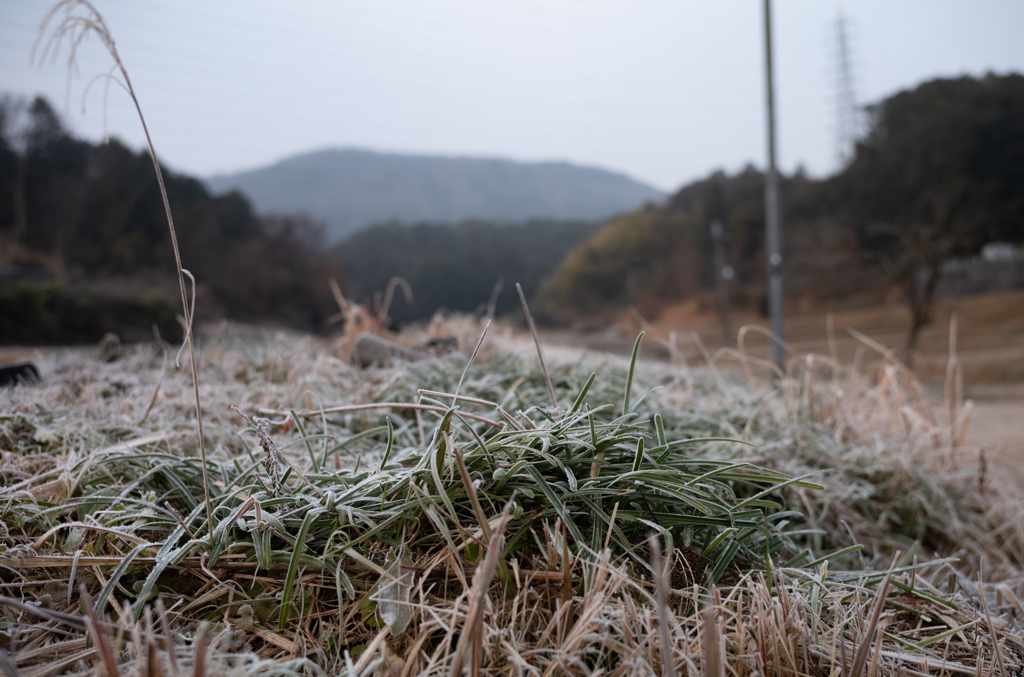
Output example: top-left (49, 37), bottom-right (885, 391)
top-left (0, 96), bottom-right (338, 330)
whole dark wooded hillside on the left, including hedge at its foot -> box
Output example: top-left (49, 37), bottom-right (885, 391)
top-left (0, 96), bottom-right (337, 342)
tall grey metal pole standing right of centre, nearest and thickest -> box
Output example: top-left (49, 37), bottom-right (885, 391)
top-left (765, 0), bottom-right (785, 367)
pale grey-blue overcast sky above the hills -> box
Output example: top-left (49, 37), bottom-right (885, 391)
top-left (0, 0), bottom-right (1024, 189)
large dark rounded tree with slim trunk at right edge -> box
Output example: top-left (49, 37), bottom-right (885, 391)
top-left (836, 75), bottom-right (1024, 363)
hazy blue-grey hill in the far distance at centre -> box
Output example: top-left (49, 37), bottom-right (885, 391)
top-left (207, 149), bottom-right (665, 242)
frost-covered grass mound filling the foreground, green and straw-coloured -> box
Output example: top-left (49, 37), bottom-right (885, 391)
top-left (0, 318), bottom-right (1024, 677)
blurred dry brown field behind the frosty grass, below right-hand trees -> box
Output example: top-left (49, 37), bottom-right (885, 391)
top-left (551, 291), bottom-right (1024, 480)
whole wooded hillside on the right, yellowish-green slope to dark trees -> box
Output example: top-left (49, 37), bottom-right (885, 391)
top-left (537, 75), bottom-right (1024, 347)
